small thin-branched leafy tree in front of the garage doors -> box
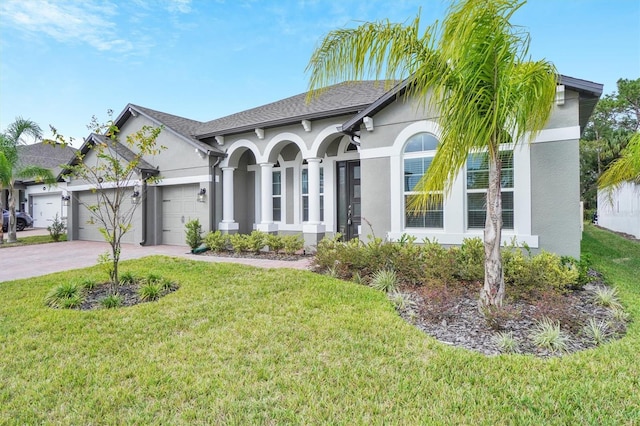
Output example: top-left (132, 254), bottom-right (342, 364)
top-left (52, 111), bottom-right (165, 294)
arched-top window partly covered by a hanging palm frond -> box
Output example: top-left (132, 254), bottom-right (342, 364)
top-left (403, 133), bottom-right (444, 228)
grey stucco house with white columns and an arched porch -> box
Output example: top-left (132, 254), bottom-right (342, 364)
top-left (68, 76), bottom-right (602, 257)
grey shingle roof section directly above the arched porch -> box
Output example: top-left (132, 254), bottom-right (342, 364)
top-left (198, 81), bottom-right (396, 139)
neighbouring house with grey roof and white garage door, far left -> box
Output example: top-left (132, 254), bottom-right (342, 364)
top-left (2, 142), bottom-right (76, 228)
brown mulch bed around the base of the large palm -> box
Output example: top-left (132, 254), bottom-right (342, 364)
top-left (400, 272), bottom-right (626, 357)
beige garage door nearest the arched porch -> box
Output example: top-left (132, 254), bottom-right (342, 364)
top-left (162, 184), bottom-right (209, 246)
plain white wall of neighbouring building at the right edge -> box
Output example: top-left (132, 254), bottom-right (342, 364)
top-left (598, 183), bottom-right (640, 238)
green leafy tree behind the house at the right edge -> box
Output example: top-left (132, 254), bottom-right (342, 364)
top-left (580, 78), bottom-right (640, 209)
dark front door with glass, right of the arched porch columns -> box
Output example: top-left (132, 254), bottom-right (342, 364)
top-left (337, 160), bottom-right (361, 241)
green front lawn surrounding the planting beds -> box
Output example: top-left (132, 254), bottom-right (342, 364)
top-left (0, 227), bottom-right (640, 425)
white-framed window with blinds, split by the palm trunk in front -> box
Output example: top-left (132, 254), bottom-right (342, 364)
top-left (467, 151), bottom-right (513, 229)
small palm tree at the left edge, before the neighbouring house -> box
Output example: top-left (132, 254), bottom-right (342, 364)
top-left (0, 117), bottom-right (55, 244)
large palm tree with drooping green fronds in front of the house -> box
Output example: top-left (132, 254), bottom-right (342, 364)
top-left (307, 0), bottom-right (557, 306)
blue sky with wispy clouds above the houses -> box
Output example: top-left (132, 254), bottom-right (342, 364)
top-left (0, 0), bottom-right (640, 146)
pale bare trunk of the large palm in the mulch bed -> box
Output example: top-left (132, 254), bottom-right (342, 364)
top-left (480, 149), bottom-right (504, 307)
